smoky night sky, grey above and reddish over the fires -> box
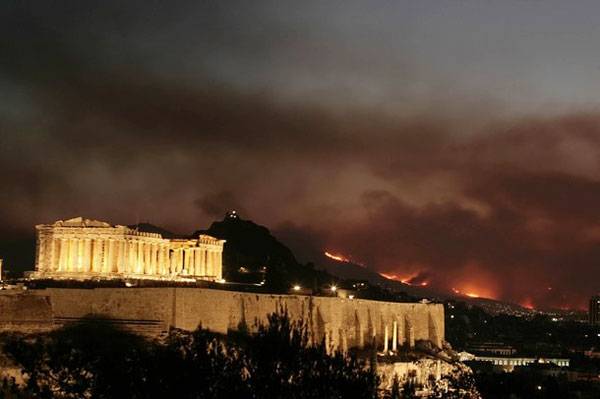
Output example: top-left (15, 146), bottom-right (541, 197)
top-left (0, 0), bottom-right (600, 307)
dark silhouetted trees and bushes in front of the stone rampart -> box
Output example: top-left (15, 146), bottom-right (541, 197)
top-left (0, 314), bottom-right (379, 399)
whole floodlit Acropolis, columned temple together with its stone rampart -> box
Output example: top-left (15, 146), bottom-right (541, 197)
top-left (0, 218), bottom-right (444, 350)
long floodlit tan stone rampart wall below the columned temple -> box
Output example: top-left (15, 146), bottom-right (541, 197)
top-left (0, 288), bottom-right (444, 350)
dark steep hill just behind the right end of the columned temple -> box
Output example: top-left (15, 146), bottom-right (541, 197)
top-left (194, 214), bottom-right (335, 291)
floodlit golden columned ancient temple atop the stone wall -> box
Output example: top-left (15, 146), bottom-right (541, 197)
top-left (30, 217), bottom-right (225, 281)
